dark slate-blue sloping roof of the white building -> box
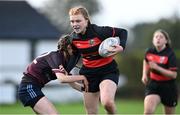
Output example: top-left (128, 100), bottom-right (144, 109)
top-left (0, 1), bottom-right (61, 39)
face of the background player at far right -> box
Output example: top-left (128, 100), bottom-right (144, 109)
top-left (153, 32), bottom-right (167, 48)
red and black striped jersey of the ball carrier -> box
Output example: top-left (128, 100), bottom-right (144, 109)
top-left (72, 24), bottom-right (127, 74)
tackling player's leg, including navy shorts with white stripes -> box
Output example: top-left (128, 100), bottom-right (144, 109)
top-left (18, 83), bottom-right (57, 114)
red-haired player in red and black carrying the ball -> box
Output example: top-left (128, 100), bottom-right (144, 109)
top-left (69, 6), bottom-right (127, 114)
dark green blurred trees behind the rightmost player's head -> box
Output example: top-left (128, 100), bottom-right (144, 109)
top-left (132, 16), bottom-right (180, 49)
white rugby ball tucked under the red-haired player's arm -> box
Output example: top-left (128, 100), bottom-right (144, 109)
top-left (98, 37), bottom-right (120, 57)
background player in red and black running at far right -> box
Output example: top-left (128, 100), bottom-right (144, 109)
top-left (142, 29), bottom-right (178, 114)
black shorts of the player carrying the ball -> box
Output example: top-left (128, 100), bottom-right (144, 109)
top-left (85, 71), bottom-right (119, 92)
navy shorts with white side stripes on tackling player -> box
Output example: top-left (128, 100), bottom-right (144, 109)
top-left (18, 82), bottom-right (44, 108)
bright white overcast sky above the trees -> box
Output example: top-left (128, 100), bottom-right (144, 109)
top-left (28, 0), bottom-right (180, 26)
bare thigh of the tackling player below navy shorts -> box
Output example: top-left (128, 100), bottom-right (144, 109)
top-left (33, 97), bottom-right (58, 115)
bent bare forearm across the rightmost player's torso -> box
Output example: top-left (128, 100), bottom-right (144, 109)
top-left (149, 62), bottom-right (177, 79)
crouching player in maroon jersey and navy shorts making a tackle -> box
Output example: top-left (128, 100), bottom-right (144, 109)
top-left (18, 35), bottom-right (88, 115)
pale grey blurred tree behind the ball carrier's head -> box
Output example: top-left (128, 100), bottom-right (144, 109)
top-left (35, 0), bottom-right (99, 32)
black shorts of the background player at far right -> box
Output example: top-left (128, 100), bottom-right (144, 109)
top-left (145, 80), bottom-right (178, 107)
